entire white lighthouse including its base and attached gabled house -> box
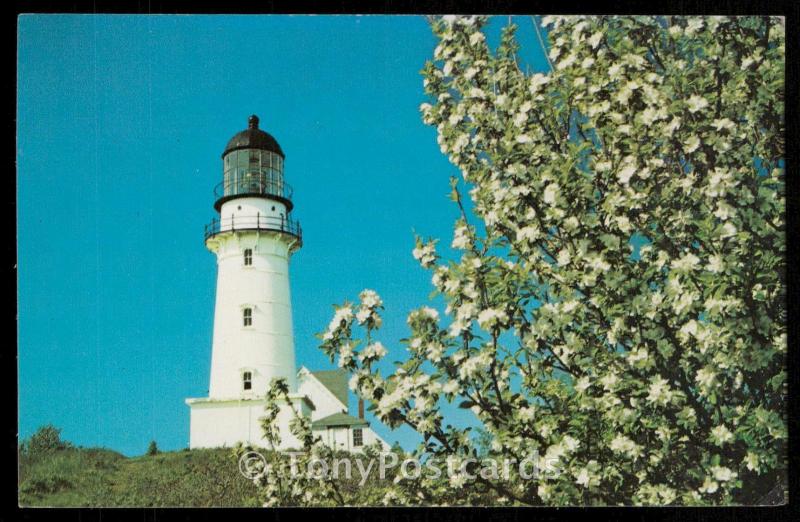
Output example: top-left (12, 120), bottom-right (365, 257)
top-left (186, 115), bottom-right (389, 452)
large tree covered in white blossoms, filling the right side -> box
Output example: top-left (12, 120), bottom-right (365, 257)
top-left (260, 17), bottom-right (787, 505)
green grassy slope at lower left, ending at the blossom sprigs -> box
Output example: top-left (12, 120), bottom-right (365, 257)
top-left (19, 442), bottom-right (259, 507)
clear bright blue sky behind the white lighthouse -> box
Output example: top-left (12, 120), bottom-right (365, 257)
top-left (17, 15), bottom-right (546, 455)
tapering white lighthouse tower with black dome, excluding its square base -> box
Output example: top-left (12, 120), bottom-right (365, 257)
top-left (205, 115), bottom-right (302, 399)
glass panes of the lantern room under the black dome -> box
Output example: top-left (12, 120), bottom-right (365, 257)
top-left (223, 149), bottom-right (284, 196)
